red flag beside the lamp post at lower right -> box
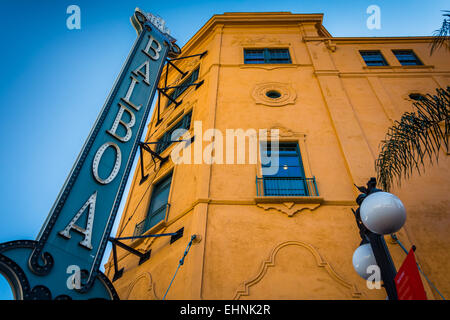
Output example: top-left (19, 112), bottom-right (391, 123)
top-left (394, 249), bottom-right (427, 300)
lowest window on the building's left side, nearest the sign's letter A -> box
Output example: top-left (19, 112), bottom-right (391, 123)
top-left (142, 174), bottom-right (172, 233)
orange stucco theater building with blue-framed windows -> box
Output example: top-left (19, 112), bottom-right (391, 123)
top-left (105, 12), bottom-right (450, 300)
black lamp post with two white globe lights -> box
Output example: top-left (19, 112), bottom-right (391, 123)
top-left (353, 178), bottom-right (406, 300)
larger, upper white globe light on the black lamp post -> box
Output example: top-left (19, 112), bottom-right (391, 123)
top-left (360, 192), bottom-right (406, 234)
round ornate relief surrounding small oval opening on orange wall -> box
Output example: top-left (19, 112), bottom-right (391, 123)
top-left (252, 82), bottom-right (297, 107)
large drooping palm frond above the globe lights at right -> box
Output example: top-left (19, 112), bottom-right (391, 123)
top-left (375, 87), bottom-right (450, 191)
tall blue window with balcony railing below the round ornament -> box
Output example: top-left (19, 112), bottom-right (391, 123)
top-left (257, 143), bottom-right (317, 196)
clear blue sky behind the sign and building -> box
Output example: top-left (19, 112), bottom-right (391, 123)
top-left (0, 0), bottom-right (450, 299)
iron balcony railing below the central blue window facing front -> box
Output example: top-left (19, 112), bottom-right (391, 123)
top-left (256, 177), bottom-right (319, 197)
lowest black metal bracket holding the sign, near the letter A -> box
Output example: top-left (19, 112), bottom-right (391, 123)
top-left (109, 227), bottom-right (184, 281)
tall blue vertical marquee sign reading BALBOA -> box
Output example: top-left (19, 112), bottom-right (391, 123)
top-left (0, 9), bottom-right (179, 299)
